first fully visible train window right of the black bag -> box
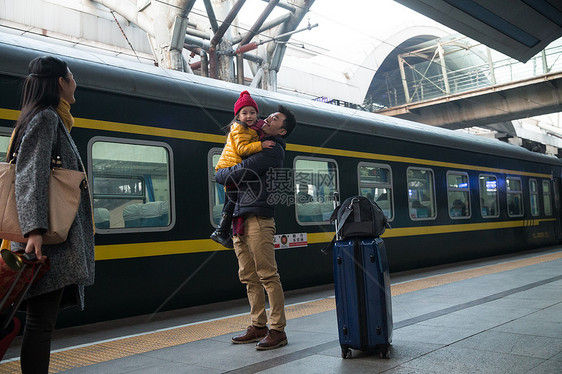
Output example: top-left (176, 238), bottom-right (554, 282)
top-left (406, 168), bottom-right (437, 220)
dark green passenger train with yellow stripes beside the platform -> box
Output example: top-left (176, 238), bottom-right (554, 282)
top-left (0, 35), bottom-right (562, 326)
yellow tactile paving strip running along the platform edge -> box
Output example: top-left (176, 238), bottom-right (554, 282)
top-left (0, 251), bottom-right (562, 374)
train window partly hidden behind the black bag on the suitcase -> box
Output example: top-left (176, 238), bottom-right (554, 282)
top-left (357, 162), bottom-right (394, 220)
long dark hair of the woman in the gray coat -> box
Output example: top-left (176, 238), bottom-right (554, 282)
top-left (6, 56), bottom-right (68, 160)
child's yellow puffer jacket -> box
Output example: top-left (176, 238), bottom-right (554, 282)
top-left (215, 122), bottom-right (262, 170)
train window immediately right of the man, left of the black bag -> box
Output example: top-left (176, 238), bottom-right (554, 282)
top-left (294, 157), bottom-right (339, 225)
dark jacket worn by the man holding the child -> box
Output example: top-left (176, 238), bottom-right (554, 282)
top-left (216, 137), bottom-right (284, 217)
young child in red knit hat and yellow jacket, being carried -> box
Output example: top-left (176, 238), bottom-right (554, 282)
top-left (211, 91), bottom-right (275, 248)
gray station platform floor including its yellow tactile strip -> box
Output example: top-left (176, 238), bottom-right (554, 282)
top-left (0, 247), bottom-right (562, 374)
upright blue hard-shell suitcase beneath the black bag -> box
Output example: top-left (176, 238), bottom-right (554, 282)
top-left (333, 238), bottom-right (392, 358)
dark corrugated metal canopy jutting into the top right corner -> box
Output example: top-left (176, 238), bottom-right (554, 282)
top-left (395, 0), bottom-right (562, 62)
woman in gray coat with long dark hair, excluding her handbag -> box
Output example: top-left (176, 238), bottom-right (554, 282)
top-left (8, 57), bottom-right (94, 374)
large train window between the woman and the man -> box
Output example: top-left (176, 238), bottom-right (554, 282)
top-left (88, 137), bottom-right (173, 233)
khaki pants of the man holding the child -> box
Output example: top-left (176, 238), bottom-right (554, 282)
top-left (233, 216), bottom-right (286, 331)
